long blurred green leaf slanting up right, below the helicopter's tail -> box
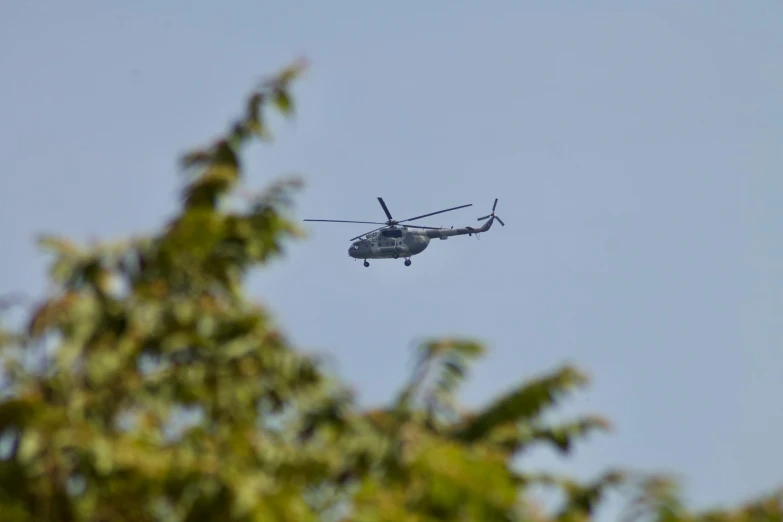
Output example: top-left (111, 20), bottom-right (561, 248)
top-left (454, 367), bottom-right (587, 443)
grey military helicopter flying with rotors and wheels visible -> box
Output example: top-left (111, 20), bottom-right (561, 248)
top-left (305, 198), bottom-right (506, 267)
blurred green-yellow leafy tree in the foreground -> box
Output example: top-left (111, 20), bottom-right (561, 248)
top-left (0, 59), bottom-right (783, 522)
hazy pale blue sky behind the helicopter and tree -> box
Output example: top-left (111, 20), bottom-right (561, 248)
top-left (0, 0), bottom-right (783, 507)
